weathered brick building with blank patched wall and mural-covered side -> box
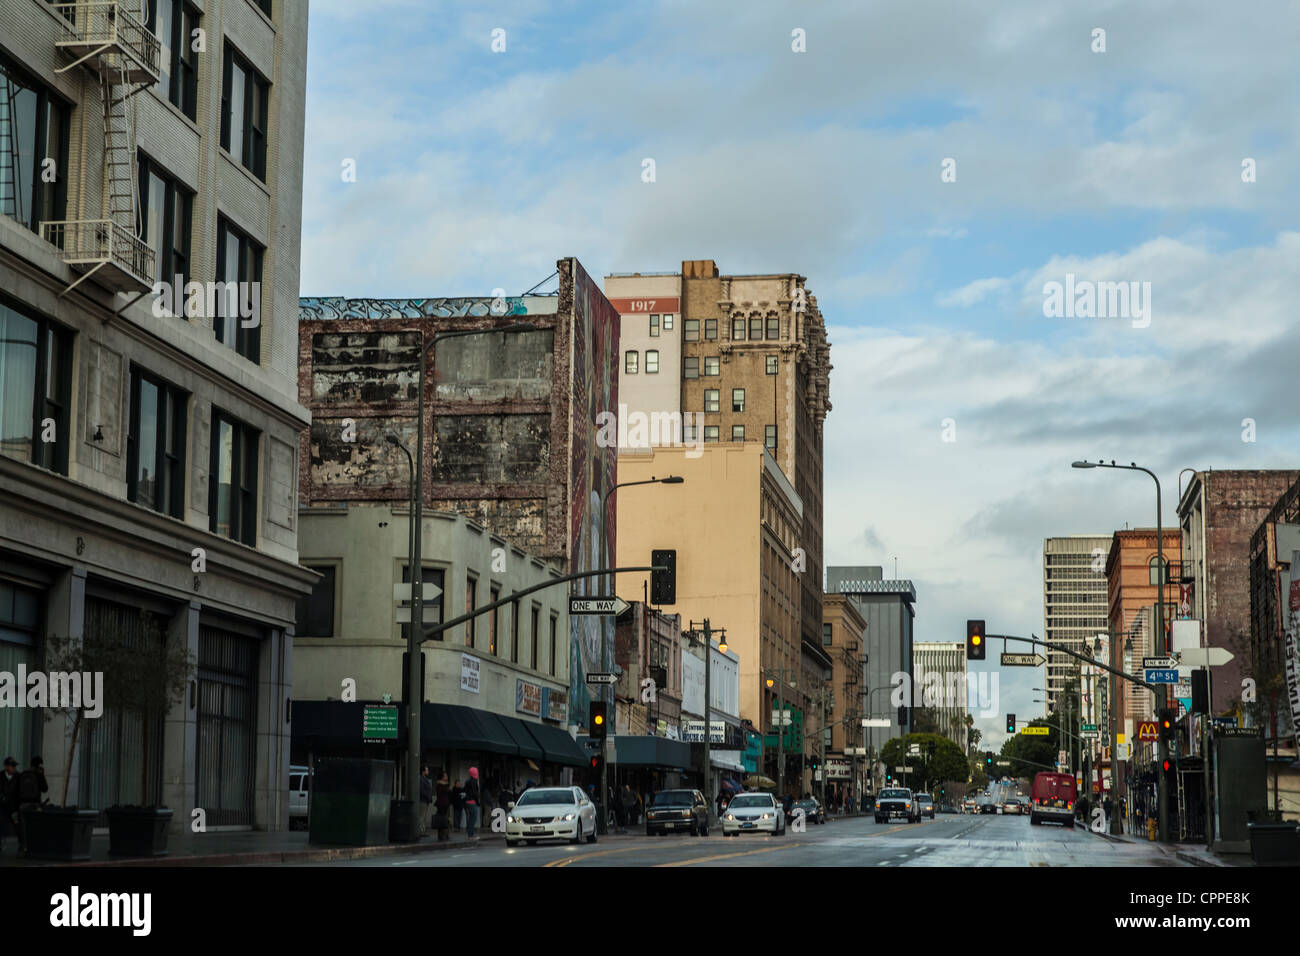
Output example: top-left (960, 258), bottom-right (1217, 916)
top-left (298, 259), bottom-right (619, 714)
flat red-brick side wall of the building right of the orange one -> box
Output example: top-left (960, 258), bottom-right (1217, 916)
top-left (1201, 471), bottom-right (1300, 711)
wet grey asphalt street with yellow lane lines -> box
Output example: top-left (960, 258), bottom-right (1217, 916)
top-left (295, 816), bottom-right (1188, 866)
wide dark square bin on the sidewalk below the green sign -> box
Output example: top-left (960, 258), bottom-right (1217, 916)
top-left (308, 758), bottom-right (397, 847)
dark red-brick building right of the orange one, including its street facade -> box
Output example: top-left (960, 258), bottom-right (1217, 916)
top-left (1175, 471), bottom-right (1300, 714)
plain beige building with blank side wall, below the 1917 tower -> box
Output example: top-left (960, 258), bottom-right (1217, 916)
top-left (618, 442), bottom-right (800, 788)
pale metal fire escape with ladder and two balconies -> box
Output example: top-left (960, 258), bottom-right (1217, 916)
top-left (40, 0), bottom-right (161, 295)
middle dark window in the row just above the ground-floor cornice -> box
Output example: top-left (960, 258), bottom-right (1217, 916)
top-left (126, 367), bottom-right (189, 518)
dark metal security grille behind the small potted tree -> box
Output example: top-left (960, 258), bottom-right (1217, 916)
top-left (78, 597), bottom-right (165, 826)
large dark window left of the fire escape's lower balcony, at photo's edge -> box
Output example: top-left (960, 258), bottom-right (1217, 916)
top-left (0, 53), bottom-right (69, 233)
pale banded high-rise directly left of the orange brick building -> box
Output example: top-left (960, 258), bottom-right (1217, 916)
top-left (1043, 535), bottom-right (1110, 713)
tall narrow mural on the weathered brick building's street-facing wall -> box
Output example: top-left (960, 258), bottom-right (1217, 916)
top-left (569, 259), bottom-right (619, 723)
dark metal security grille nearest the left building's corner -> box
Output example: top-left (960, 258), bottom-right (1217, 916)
top-left (196, 626), bottom-right (259, 826)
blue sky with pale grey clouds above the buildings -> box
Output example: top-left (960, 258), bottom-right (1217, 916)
top-left (300, 0), bottom-right (1300, 748)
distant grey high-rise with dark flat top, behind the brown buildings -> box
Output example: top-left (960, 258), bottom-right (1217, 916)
top-left (826, 566), bottom-right (917, 790)
